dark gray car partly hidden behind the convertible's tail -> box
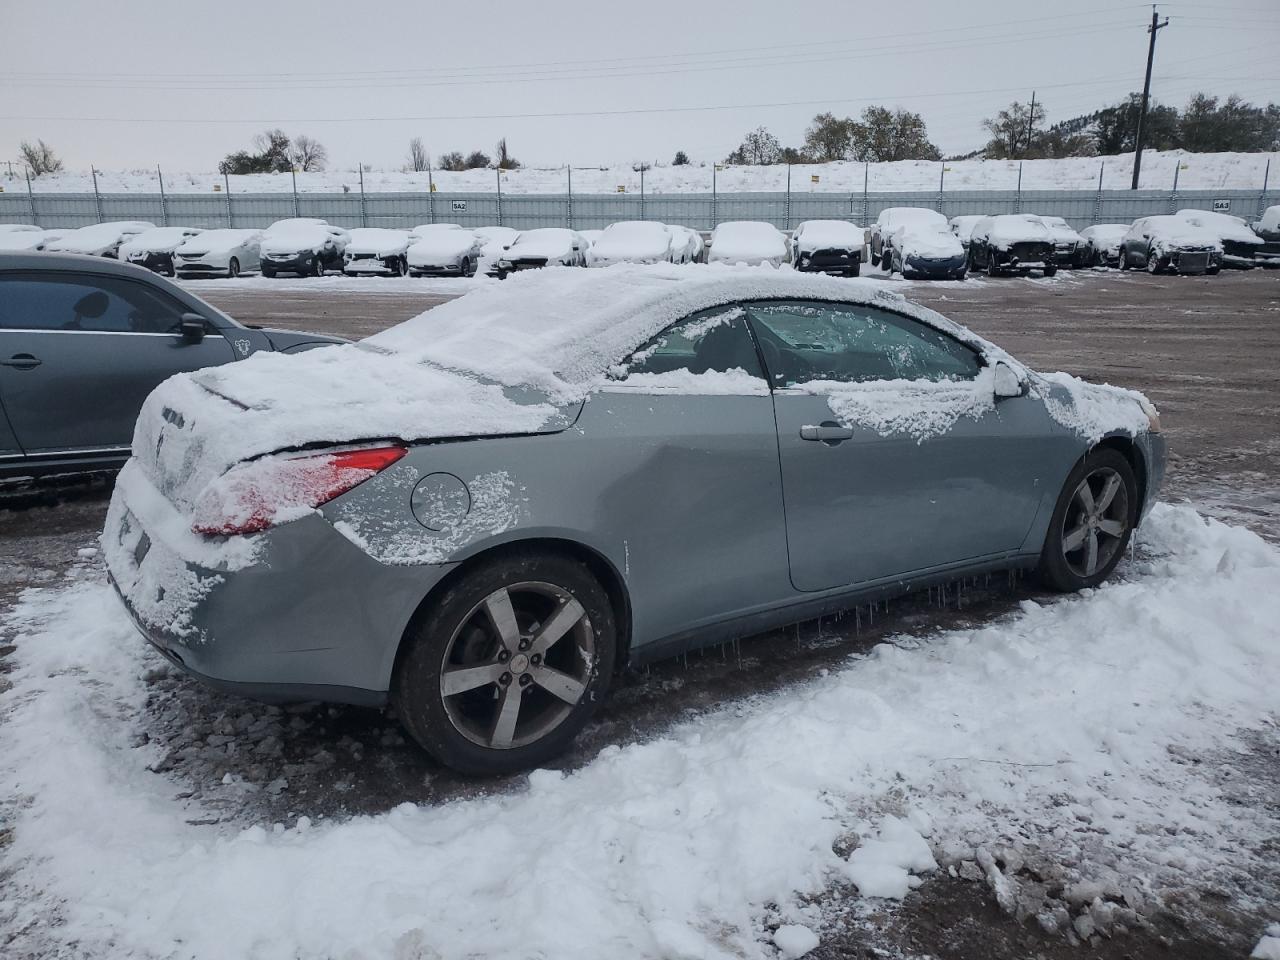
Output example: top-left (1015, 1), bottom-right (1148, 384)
top-left (0, 253), bottom-right (342, 481)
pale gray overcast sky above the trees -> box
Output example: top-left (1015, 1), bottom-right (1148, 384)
top-left (0, 0), bottom-right (1280, 170)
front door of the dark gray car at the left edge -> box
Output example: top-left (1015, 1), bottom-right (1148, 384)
top-left (0, 270), bottom-right (234, 456)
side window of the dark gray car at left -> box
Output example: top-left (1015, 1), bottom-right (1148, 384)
top-left (0, 273), bottom-right (186, 333)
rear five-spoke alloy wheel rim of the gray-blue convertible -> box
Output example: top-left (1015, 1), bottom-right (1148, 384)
top-left (440, 581), bottom-right (596, 750)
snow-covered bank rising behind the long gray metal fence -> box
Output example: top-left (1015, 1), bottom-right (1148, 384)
top-left (10, 150), bottom-right (1280, 193)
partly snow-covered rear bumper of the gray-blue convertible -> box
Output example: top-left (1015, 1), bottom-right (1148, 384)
top-left (102, 462), bottom-right (448, 705)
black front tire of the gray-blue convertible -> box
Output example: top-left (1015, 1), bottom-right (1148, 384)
top-left (1037, 447), bottom-right (1139, 591)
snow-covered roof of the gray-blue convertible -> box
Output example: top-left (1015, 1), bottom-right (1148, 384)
top-left (371, 264), bottom-right (989, 401)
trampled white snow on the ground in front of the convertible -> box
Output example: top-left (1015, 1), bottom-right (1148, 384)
top-left (0, 506), bottom-right (1280, 960)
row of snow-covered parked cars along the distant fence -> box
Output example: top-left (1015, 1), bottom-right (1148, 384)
top-left (0, 206), bottom-right (1280, 279)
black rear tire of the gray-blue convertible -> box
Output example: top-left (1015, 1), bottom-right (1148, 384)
top-left (392, 552), bottom-right (617, 774)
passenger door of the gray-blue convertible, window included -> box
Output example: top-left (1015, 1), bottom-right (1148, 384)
top-left (745, 301), bottom-right (1061, 591)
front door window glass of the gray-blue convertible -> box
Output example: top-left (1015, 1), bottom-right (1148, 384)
top-left (746, 301), bottom-right (982, 387)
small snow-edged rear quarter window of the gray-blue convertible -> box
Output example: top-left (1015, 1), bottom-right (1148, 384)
top-left (614, 307), bottom-right (764, 381)
